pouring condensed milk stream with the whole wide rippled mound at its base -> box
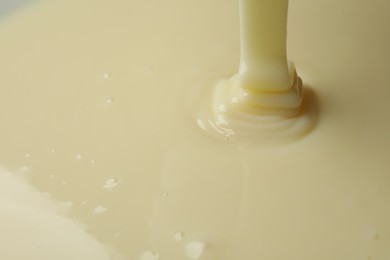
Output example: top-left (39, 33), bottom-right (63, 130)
top-left (198, 0), bottom-right (316, 143)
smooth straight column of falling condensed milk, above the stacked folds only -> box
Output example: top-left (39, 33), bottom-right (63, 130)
top-left (239, 0), bottom-right (291, 92)
